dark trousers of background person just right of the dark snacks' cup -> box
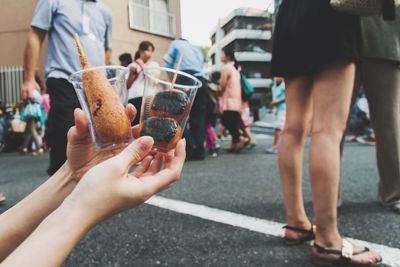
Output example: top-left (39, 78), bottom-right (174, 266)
top-left (176, 70), bottom-right (207, 159)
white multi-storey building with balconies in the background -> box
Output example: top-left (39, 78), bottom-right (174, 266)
top-left (208, 9), bottom-right (272, 100)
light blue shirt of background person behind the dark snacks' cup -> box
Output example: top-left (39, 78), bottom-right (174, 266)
top-left (163, 39), bottom-right (204, 76)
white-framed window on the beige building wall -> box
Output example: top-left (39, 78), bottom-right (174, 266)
top-left (129, 0), bottom-right (175, 37)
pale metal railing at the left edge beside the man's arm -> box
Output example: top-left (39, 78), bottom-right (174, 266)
top-left (0, 66), bottom-right (24, 105)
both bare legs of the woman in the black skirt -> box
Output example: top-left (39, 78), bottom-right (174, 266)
top-left (279, 62), bottom-right (380, 264)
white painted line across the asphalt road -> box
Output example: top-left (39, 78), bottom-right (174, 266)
top-left (146, 196), bottom-right (400, 267)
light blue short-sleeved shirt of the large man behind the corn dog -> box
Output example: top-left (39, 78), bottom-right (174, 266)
top-left (31, 0), bottom-right (111, 79)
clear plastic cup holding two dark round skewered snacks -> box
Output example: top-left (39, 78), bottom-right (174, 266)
top-left (140, 67), bottom-right (202, 152)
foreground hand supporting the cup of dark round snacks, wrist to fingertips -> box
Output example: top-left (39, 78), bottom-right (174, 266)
top-left (64, 136), bottom-right (186, 226)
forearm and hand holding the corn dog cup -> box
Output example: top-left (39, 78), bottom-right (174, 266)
top-left (0, 104), bottom-right (138, 262)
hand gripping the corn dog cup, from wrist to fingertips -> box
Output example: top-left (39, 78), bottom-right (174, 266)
top-left (65, 104), bottom-right (138, 181)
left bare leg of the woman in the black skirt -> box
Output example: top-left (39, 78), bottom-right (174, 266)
top-left (279, 77), bottom-right (312, 238)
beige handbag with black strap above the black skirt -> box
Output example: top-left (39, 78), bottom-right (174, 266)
top-left (330, 0), bottom-right (400, 20)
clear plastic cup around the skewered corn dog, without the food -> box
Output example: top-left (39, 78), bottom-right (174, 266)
top-left (68, 66), bottom-right (132, 149)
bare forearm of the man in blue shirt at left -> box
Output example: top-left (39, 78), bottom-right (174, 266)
top-left (24, 29), bottom-right (45, 81)
